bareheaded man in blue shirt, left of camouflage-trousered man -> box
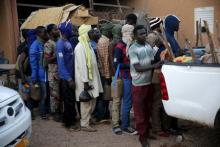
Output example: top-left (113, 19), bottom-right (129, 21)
top-left (29, 26), bottom-right (49, 119)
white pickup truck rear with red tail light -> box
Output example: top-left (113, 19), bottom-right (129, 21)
top-left (160, 62), bottom-right (220, 128)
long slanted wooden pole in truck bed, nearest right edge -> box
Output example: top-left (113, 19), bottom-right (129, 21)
top-left (204, 20), bottom-right (219, 64)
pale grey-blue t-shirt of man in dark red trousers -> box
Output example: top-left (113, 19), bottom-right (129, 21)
top-left (129, 42), bottom-right (154, 86)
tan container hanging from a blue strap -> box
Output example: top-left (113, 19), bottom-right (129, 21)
top-left (111, 64), bottom-right (123, 98)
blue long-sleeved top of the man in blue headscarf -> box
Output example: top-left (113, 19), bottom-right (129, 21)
top-left (56, 39), bottom-right (74, 81)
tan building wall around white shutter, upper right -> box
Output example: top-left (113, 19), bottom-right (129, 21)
top-left (128, 0), bottom-right (220, 46)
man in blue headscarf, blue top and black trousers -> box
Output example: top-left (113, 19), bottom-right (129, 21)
top-left (56, 22), bottom-right (77, 130)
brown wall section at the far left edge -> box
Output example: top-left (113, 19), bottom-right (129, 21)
top-left (0, 0), bottom-right (19, 63)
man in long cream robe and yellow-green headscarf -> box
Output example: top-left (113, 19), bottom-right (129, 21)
top-left (75, 24), bottom-right (103, 132)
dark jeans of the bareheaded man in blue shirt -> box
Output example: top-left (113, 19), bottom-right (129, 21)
top-left (40, 82), bottom-right (47, 116)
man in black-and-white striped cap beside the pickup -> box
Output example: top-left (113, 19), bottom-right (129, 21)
top-left (147, 17), bottom-right (169, 137)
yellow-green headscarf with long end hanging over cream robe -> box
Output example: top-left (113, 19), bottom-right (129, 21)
top-left (78, 24), bottom-right (93, 80)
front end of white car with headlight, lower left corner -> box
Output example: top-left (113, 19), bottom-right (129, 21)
top-left (0, 86), bottom-right (32, 147)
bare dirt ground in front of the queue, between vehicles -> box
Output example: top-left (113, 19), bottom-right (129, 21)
top-left (30, 118), bottom-right (175, 147)
